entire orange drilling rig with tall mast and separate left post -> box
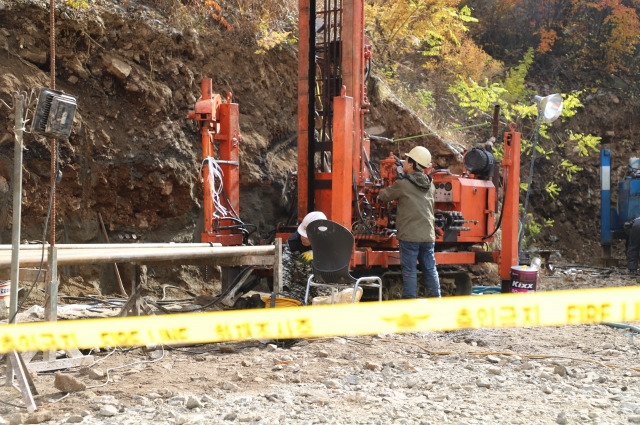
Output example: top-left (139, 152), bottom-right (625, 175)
top-left (189, 0), bottom-right (520, 299)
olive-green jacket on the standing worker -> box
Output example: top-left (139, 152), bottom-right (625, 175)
top-left (378, 171), bottom-right (436, 242)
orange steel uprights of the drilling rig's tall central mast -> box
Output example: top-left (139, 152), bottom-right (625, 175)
top-left (298, 0), bottom-right (370, 228)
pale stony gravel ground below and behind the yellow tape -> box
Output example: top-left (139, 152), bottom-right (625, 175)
top-left (0, 271), bottom-right (640, 425)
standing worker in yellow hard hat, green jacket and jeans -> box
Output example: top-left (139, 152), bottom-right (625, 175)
top-left (378, 146), bottom-right (440, 298)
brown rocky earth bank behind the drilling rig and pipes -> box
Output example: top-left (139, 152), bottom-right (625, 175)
top-left (0, 0), bottom-right (462, 290)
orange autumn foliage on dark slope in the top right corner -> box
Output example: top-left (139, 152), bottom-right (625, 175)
top-left (468, 0), bottom-right (640, 79)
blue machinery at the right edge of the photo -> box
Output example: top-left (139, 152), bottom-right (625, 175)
top-left (600, 149), bottom-right (640, 261)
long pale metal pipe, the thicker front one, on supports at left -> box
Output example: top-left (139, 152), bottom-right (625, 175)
top-left (0, 245), bottom-right (275, 268)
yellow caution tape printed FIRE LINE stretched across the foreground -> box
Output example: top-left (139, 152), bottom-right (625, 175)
top-left (0, 287), bottom-right (640, 353)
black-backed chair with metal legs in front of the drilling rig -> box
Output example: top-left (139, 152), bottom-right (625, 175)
top-left (304, 220), bottom-right (382, 305)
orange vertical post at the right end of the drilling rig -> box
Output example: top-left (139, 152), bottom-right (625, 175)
top-left (498, 123), bottom-right (520, 280)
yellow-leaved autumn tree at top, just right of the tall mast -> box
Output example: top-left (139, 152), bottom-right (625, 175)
top-left (365, 0), bottom-right (501, 109)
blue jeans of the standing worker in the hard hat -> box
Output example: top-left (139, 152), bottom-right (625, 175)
top-left (400, 241), bottom-right (440, 298)
